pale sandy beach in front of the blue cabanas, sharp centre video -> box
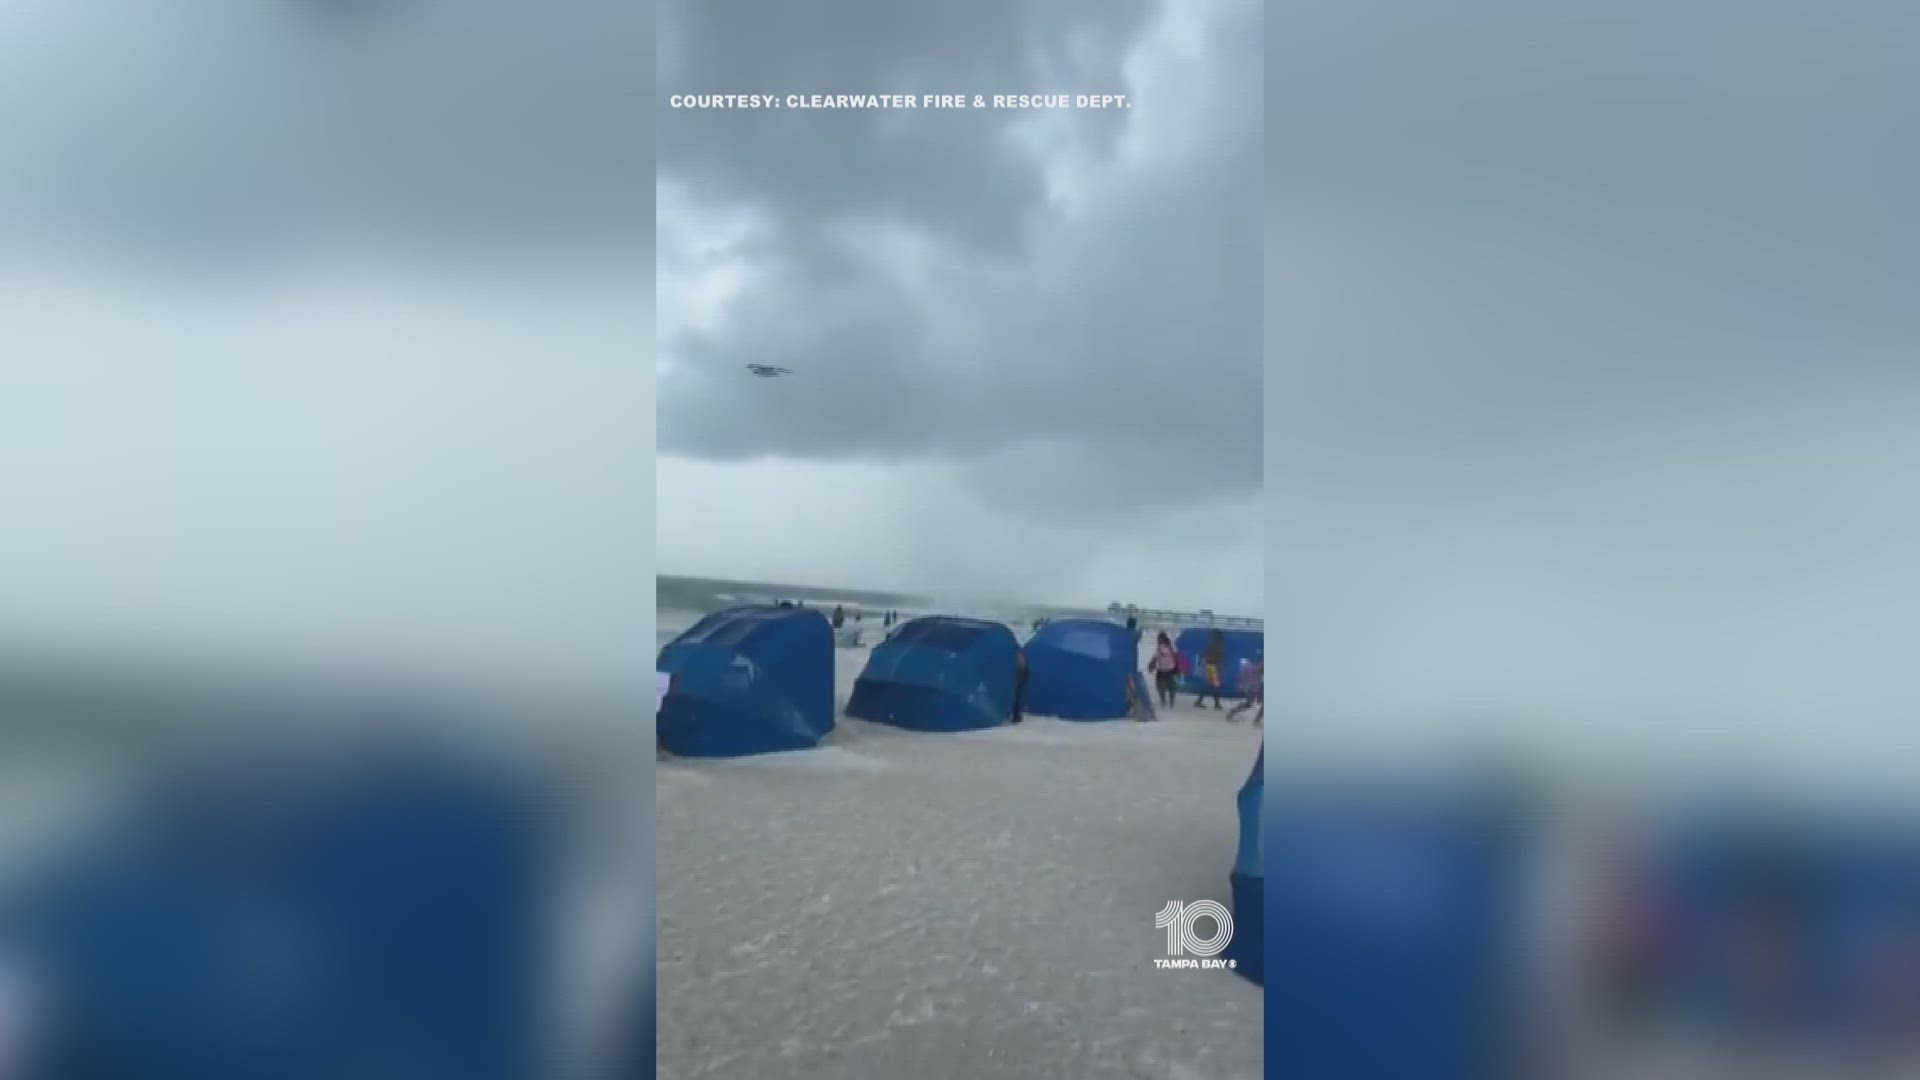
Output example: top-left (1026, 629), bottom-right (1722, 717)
top-left (655, 634), bottom-right (1261, 1080)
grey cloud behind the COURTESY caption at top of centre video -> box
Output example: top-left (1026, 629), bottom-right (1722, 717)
top-left (659, 0), bottom-right (1148, 254)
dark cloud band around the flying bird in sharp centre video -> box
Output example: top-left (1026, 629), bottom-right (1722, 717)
top-left (662, 148), bottom-right (1260, 466)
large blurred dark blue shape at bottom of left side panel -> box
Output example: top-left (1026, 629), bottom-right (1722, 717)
top-left (6, 749), bottom-right (551, 1080)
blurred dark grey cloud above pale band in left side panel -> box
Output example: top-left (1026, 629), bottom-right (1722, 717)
top-left (0, 0), bottom-right (653, 258)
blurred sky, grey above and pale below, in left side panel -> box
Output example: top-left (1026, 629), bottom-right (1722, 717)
top-left (0, 0), bottom-right (653, 675)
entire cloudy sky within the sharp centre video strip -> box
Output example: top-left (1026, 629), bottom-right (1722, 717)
top-left (657, 0), bottom-right (1263, 613)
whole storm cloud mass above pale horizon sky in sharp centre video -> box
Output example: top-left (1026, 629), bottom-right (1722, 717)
top-left (660, 4), bottom-right (1261, 511)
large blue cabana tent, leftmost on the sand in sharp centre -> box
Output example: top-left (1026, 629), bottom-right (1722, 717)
top-left (657, 607), bottom-right (833, 757)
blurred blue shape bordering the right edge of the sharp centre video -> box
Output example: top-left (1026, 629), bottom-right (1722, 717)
top-left (1265, 776), bottom-right (1523, 1080)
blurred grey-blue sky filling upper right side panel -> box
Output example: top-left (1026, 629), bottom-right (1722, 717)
top-left (1265, 0), bottom-right (1920, 776)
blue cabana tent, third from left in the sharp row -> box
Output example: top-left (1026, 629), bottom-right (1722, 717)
top-left (1027, 619), bottom-right (1152, 721)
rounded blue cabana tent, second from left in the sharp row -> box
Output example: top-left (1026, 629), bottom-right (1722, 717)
top-left (847, 615), bottom-right (1020, 732)
